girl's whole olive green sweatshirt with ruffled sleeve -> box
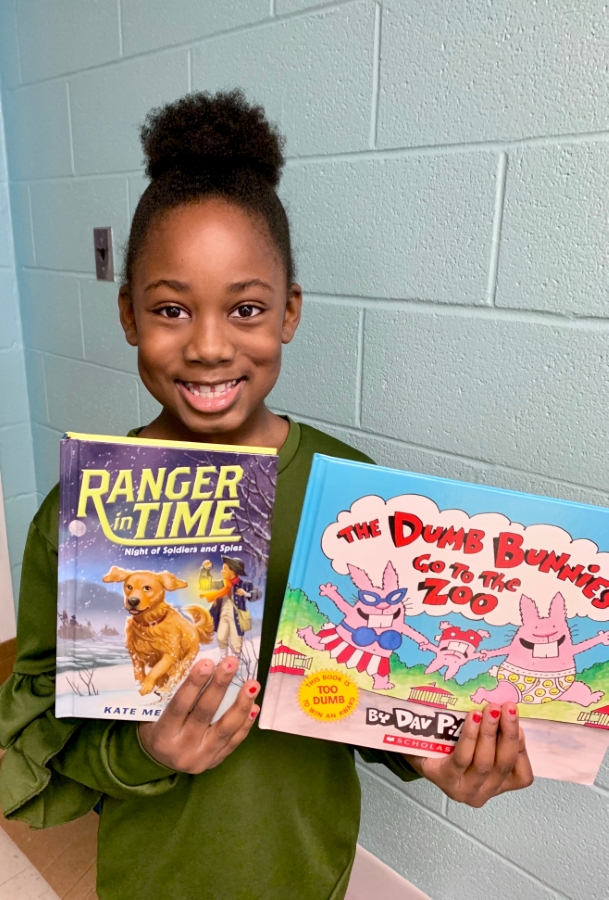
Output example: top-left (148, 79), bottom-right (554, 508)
top-left (0, 422), bottom-right (417, 900)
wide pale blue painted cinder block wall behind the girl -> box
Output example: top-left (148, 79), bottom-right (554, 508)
top-left (0, 0), bottom-right (609, 900)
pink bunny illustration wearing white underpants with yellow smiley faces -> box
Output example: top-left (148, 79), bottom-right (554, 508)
top-left (471, 593), bottom-right (609, 706)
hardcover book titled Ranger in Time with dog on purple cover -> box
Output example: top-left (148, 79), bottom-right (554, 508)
top-left (55, 434), bottom-right (277, 721)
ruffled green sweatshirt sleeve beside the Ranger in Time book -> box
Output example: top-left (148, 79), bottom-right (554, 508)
top-left (0, 489), bottom-right (183, 828)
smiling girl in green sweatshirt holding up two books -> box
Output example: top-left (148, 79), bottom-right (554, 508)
top-left (0, 91), bottom-right (532, 900)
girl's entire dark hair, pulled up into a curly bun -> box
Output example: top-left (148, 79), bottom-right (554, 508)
top-left (123, 90), bottom-right (295, 285)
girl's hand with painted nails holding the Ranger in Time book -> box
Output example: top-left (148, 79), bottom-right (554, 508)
top-left (139, 656), bottom-right (260, 775)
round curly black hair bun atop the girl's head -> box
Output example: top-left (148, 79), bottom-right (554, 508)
top-left (140, 90), bottom-right (285, 187)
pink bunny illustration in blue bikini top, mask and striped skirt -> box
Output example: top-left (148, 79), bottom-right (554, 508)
top-left (298, 562), bottom-right (435, 691)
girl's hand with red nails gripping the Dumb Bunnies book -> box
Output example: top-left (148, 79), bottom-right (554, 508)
top-left (405, 703), bottom-right (533, 808)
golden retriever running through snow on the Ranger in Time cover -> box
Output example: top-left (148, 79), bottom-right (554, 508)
top-left (102, 566), bottom-right (214, 695)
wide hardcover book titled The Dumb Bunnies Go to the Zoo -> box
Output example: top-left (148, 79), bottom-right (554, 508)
top-left (260, 455), bottom-right (609, 756)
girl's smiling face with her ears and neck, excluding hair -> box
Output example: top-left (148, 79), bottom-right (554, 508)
top-left (119, 199), bottom-right (302, 443)
